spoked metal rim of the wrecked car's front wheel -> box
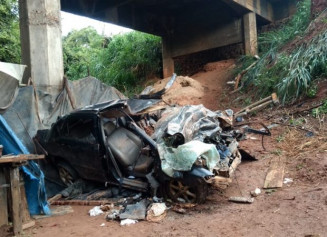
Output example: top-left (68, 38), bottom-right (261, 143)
top-left (169, 180), bottom-right (196, 203)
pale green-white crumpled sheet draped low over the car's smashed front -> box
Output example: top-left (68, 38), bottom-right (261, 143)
top-left (158, 140), bottom-right (220, 177)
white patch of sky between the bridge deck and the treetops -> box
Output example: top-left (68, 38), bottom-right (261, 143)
top-left (61, 11), bottom-right (132, 36)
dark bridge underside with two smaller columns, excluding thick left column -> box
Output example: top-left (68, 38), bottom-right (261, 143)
top-left (61, 0), bottom-right (295, 76)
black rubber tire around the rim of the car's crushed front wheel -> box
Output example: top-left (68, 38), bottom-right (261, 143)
top-left (165, 176), bottom-right (208, 204)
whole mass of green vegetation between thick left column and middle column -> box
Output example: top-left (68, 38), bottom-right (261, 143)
top-left (63, 28), bottom-right (161, 94)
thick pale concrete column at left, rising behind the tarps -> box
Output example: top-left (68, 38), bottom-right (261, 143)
top-left (19, 0), bottom-right (64, 89)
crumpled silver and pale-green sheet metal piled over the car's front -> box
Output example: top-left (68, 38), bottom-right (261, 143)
top-left (152, 105), bottom-right (233, 177)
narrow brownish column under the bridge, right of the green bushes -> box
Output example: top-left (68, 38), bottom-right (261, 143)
top-left (162, 37), bottom-right (175, 78)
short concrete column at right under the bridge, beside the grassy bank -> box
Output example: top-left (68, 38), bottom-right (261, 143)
top-left (243, 12), bottom-right (258, 55)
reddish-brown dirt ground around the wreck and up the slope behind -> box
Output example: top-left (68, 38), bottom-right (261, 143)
top-left (0, 60), bottom-right (327, 237)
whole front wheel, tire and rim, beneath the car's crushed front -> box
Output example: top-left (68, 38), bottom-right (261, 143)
top-left (166, 176), bottom-right (208, 204)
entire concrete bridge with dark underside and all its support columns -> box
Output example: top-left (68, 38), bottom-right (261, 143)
top-left (19, 0), bottom-right (296, 86)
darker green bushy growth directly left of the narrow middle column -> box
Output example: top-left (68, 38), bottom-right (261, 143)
top-left (98, 31), bottom-right (161, 92)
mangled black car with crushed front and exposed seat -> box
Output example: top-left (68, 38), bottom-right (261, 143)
top-left (34, 99), bottom-right (241, 203)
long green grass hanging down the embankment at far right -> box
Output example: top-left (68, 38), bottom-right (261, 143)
top-left (240, 0), bottom-right (327, 103)
